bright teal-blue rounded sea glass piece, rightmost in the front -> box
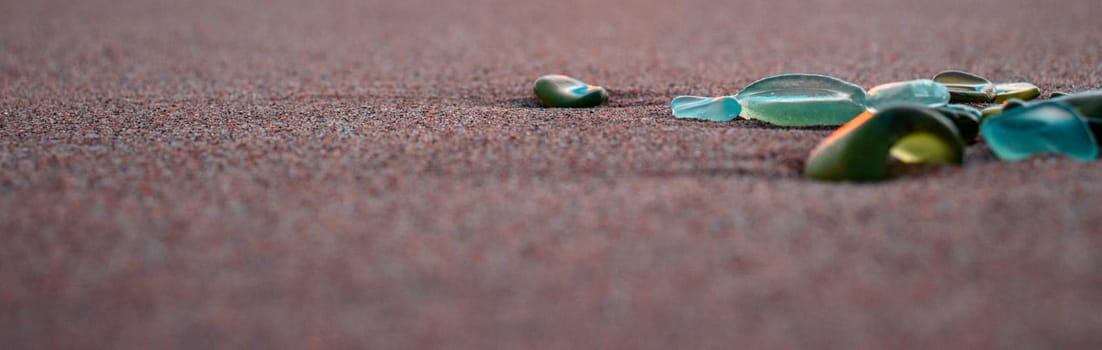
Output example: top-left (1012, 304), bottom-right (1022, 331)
top-left (980, 101), bottom-right (1099, 161)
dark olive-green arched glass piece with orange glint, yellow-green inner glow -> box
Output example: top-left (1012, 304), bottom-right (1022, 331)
top-left (803, 106), bottom-right (964, 182)
